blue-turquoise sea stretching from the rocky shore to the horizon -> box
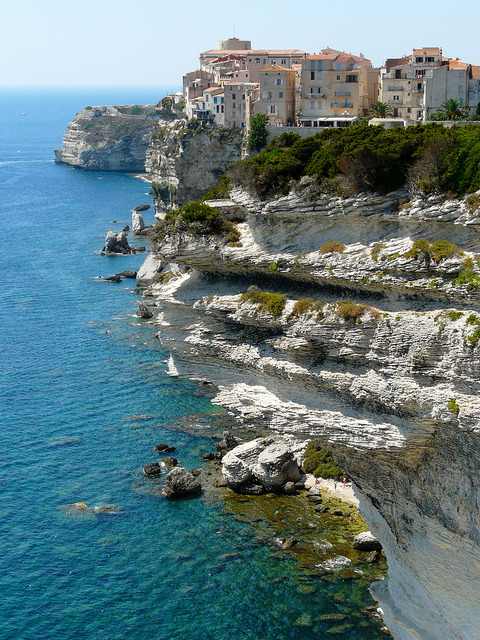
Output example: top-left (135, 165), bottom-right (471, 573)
top-left (0, 87), bottom-right (385, 640)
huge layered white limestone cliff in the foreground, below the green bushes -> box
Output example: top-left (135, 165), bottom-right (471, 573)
top-left (138, 185), bottom-right (480, 640)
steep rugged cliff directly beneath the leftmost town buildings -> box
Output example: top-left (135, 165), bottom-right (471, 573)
top-left (146, 124), bottom-right (242, 215)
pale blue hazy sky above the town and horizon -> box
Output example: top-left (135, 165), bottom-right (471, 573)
top-left (0, 0), bottom-right (480, 89)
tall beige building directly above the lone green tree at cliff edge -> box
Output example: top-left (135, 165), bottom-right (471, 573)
top-left (253, 65), bottom-right (295, 126)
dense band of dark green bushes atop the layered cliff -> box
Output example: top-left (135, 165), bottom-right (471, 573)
top-left (228, 122), bottom-right (480, 197)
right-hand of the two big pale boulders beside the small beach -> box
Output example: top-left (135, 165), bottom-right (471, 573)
top-left (253, 442), bottom-right (300, 490)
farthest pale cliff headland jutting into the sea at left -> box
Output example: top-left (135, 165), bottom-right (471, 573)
top-left (55, 106), bottom-right (158, 173)
